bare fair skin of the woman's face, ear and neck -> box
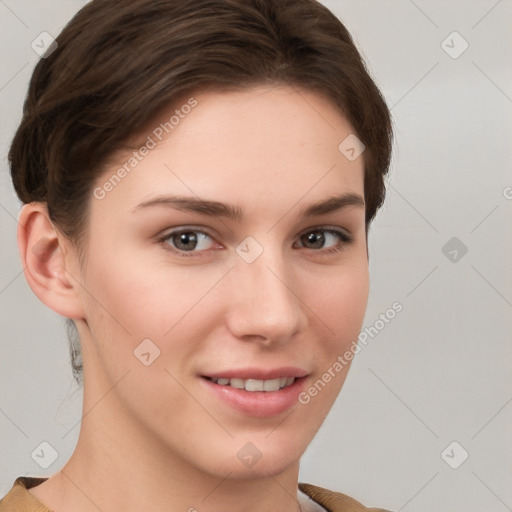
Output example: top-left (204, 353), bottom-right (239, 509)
top-left (18, 86), bottom-right (369, 512)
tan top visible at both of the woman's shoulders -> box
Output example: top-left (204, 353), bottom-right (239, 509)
top-left (0, 476), bottom-right (389, 512)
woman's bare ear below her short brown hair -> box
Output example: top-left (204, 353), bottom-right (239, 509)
top-left (18, 202), bottom-right (84, 319)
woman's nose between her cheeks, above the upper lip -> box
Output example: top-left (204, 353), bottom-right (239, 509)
top-left (226, 243), bottom-right (307, 345)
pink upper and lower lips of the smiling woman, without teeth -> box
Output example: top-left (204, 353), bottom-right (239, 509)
top-left (200, 366), bottom-right (308, 418)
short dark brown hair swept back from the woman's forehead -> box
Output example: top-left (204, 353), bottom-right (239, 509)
top-left (9, 0), bottom-right (392, 384)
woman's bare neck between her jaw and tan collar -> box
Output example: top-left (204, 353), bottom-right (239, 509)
top-left (35, 372), bottom-right (305, 512)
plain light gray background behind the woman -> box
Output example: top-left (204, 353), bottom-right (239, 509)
top-left (0, 0), bottom-right (512, 512)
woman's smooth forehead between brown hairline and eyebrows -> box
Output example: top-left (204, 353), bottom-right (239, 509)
top-left (92, 86), bottom-right (364, 218)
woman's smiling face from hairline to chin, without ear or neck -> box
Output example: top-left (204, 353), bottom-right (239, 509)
top-left (71, 87), bottom-right (369, 478)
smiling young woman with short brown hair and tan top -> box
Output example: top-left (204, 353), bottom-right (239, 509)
top-left (0, 0), bottom-right (392, 512)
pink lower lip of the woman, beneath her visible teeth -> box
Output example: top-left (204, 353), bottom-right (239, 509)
top-left (201, 377), bottom-right (305, 418)
